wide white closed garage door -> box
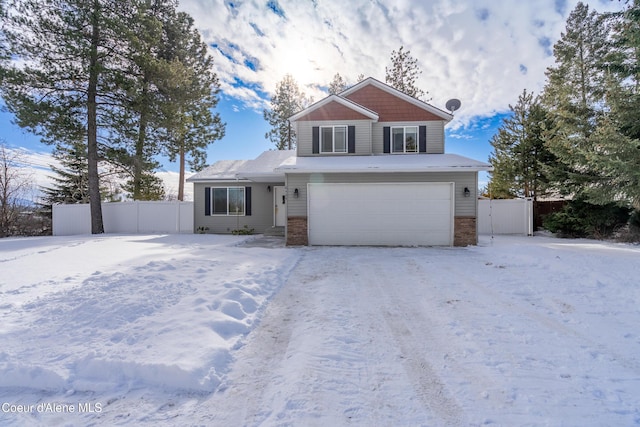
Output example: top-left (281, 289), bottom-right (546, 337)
top-left (307, 183), bottom-right (454, 246)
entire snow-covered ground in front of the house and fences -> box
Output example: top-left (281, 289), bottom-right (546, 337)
top-left (0, 235), bottom-right (640, 426)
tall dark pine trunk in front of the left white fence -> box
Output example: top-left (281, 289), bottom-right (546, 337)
top-left (87, 0), bottom-right (104, 234)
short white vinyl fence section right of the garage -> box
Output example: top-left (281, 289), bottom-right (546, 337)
top-left (478, 199), bottom-right (533, 236)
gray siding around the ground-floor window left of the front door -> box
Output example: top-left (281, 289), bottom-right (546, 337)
top-left (193, 181), bottom-right (284, 234)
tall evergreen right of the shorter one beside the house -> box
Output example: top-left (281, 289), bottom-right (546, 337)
top-left (543, 2), bottom-right (610, 195)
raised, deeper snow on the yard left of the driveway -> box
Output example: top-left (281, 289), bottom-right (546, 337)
top-left (0, 235), bottom-right (299, 392)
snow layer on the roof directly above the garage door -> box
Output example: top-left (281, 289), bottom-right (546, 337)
top-left (276, 154), bottom-right (492, 173)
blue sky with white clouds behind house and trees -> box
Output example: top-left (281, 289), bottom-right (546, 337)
top-left (0, 0), bottom-right (624, 191)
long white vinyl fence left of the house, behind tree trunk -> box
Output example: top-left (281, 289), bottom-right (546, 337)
top-left (53, 202), bottom-right (193, 236)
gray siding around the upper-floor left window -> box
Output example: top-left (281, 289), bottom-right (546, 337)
top-left (296, 120), bottom-right (371, 157)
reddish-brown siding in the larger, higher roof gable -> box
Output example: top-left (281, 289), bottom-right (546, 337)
top-left (346, 85), bottom-right (442, 122)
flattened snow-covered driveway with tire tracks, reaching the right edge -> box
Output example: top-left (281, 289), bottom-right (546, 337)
top-left (197, 241), bottom-right (640, 426)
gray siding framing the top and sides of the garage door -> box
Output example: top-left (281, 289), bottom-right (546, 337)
top-left (286, 172), bottom-right (478, 217)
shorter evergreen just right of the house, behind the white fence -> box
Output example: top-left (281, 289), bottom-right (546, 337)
top-left (488, 90), bottom-right (555, 200)
